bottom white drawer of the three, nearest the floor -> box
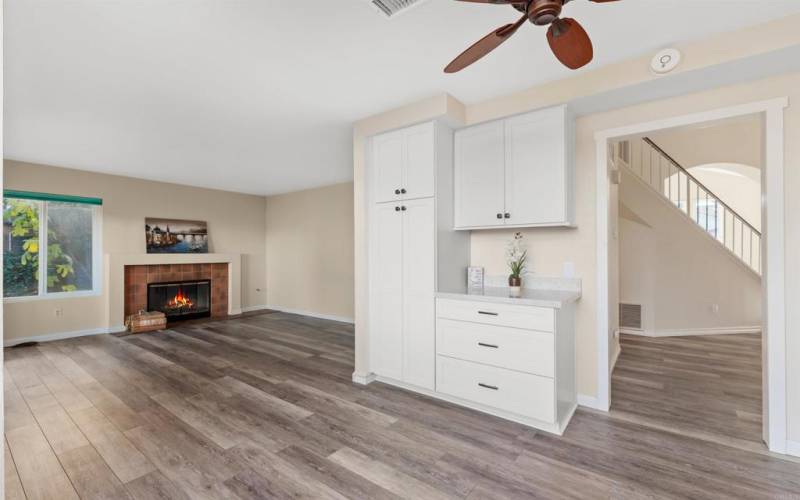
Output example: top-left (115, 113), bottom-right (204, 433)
top-left (436, 356), bottom-right (555, 423)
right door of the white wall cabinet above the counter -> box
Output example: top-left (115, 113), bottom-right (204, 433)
top-left (505, 108), bottom-right (567, 225)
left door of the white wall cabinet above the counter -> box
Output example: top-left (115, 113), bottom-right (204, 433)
top-left (454, 122), bottom-right (505, 228)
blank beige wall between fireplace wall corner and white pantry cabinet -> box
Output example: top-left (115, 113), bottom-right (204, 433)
top-left (266, 182), bottom-right (353, 321)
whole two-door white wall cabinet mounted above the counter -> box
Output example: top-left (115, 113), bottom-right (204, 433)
top-left (455, 106), bottom-right (575, 229)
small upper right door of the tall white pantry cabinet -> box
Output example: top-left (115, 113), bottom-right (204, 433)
top-left (401, 122), bottom-right (436, 200)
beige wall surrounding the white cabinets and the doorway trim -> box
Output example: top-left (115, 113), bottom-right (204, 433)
top-left (353, 16), bottom-right (800, 440)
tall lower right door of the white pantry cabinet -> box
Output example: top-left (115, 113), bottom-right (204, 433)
top-left (403, 198), bottom-right (436, 390)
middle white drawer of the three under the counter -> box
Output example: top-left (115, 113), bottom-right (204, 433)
top-left (436, 318), bottom-right (555, 377)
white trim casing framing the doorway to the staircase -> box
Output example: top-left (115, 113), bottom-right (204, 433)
top-left (592, 97), bottom-right (789, 453)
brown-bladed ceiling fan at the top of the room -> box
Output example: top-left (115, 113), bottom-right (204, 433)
top-left (444, 0), bottom-right (618, 73)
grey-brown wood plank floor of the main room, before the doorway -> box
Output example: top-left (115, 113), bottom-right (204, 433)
top-left (4, 313), bottom-right (800, 499)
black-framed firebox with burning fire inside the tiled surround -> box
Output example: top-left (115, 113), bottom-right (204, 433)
top-left (147, 280), bottom-right (211, 321)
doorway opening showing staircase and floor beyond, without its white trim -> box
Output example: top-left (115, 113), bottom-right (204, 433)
top-left (610, 114), bottom-right (764, 443)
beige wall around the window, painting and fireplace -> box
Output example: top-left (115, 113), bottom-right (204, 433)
top-left (3, 160), bottom-right (266, 342)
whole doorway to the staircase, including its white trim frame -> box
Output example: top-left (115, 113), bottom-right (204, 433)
top-left (596, 98), bottom-right (788, 453)
